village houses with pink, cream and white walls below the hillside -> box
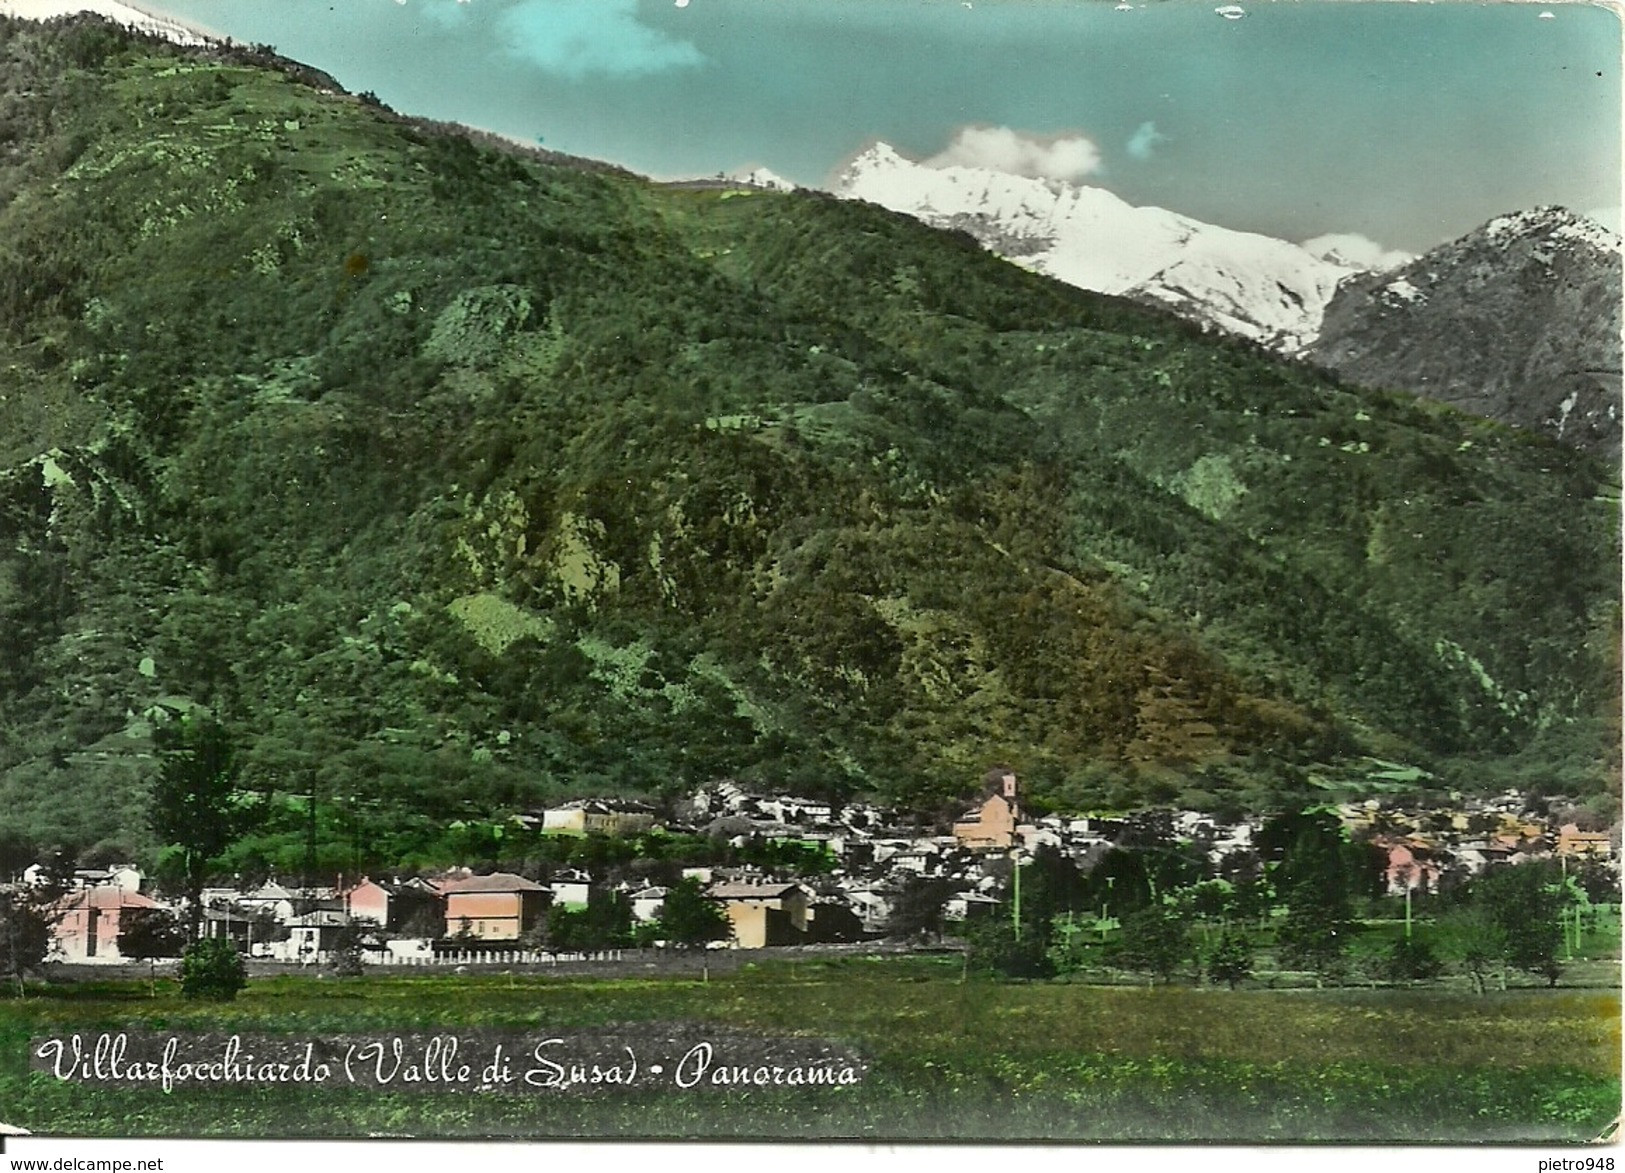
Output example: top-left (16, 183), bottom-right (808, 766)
top-left (13, 772), bottom-right (1619, 965)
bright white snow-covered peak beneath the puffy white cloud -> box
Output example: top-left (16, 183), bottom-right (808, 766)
top-left (834, 143), bottom-right (1360, 353)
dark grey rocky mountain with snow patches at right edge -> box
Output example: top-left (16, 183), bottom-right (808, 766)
top-left (1307, 208), bottom-right (1620, 458)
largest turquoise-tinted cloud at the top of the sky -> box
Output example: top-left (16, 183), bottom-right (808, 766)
top-left (499, 0), bottom-right (705, 81)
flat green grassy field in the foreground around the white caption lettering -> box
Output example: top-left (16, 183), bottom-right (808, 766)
top-left (0, 957), bottom-right (1620, 1144)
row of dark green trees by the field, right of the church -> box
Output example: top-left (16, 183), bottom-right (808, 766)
top-left (891, 809), bottom-right (1617, 993)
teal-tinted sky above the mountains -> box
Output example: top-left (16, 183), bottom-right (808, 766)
top-left (138, 0), bottom-right (1620, 250)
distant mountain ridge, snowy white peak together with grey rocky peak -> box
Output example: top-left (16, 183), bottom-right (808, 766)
top-left (834, 143), bottom-right (1622, 457)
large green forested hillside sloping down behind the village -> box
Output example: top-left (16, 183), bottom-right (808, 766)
top-left (0, 19), bottom-right (1619, 850)
